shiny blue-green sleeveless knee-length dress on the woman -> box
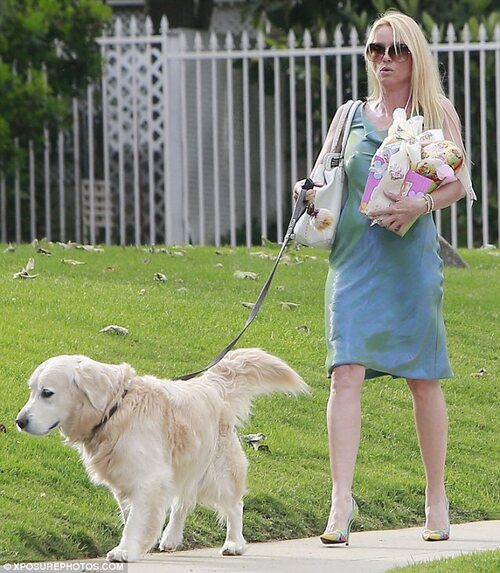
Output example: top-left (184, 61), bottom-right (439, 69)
top-left (325, 106), bottom-right (452, 379)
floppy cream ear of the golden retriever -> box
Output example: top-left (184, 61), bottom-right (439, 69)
top-left (73, 359), bottom-right (122, 412)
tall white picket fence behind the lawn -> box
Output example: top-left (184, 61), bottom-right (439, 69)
top-left (0, 19), bottom-right (500, 247)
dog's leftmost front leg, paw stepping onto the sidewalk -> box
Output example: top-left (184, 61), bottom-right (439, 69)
top-left (106, 483), bottom-right (167, 562)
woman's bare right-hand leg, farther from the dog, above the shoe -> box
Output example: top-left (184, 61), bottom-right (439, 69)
top-left (407, 380), bottom-right (448, 529)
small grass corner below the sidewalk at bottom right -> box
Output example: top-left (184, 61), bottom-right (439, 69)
top-left (390, 550), bottom-right (500, 573)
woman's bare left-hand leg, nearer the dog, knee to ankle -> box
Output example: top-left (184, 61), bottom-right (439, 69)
top-left (325, 364), bottom-right (365, 533)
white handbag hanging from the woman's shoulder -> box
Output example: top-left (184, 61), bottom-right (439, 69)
top-left (294, 100), bottom-right (362, 249)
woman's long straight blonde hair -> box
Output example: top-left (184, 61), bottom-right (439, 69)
top-left (365, 10), bottom-right (445, 129)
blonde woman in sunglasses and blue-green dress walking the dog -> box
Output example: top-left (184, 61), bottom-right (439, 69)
top-left (294, 11), bottom-right (474, 544)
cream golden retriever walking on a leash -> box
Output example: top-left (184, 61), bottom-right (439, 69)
top-left (16, 349), bottom-right (309, 562)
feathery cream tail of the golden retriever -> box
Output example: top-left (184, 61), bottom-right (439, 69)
top-left (208, 348), bottom-right (310, 424)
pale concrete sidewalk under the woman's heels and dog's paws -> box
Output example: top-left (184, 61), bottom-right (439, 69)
top-left (2, 520), bottom-right (500, 573)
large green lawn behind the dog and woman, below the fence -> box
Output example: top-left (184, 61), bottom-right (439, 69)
top-left (0, 241), bottom-right (500, 563)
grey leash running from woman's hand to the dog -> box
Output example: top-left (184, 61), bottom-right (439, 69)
top-left (172, 177), bottom-right (314, 380)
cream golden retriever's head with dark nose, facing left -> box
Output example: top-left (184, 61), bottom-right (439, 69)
top-left (16, 355), bottom-right (135, 436)
